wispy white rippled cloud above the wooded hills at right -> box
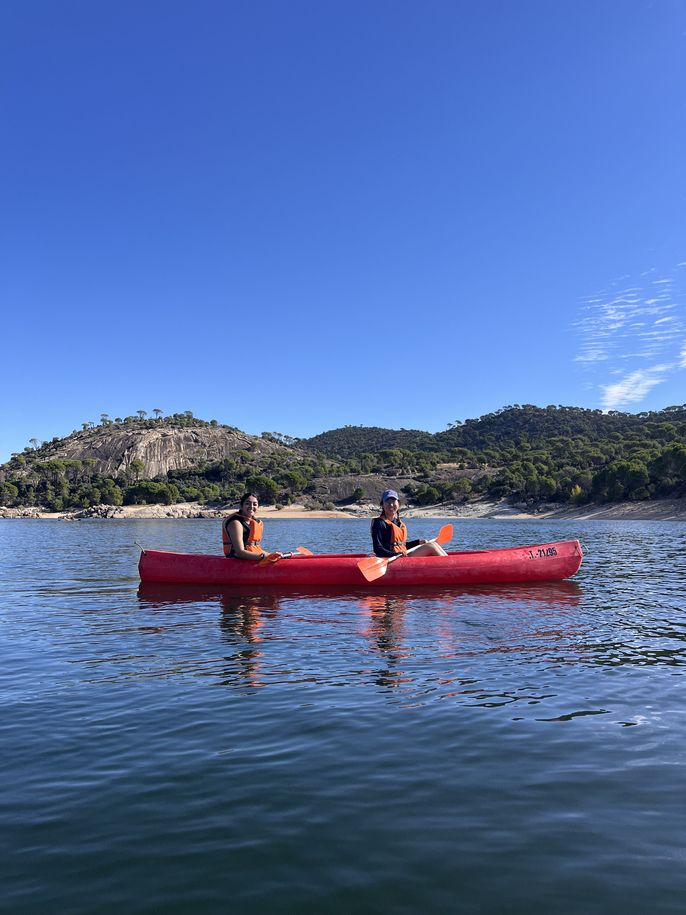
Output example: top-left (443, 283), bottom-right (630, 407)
top-left (575, 261), bottom-right (686, 410)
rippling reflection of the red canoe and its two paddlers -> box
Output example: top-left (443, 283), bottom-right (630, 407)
top-left (138, 581), bottom-right (583, 693)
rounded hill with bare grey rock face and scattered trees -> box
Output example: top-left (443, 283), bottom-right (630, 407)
top-left (0, 414), bottom-right (332, 511)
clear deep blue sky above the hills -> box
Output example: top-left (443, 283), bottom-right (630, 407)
top-left (0, 0), bottom-right (686, 460)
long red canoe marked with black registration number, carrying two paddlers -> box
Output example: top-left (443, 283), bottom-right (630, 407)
top-left (138, 540), bottom-right (583, 588)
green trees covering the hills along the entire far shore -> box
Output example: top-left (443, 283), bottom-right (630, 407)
top-left (0, 405), bottom-right (686, 511)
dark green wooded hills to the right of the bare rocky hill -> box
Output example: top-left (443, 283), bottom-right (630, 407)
top-left (300, 404), bottom-right (686, 504)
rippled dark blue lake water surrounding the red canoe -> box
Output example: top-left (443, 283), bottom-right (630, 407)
top-left (0, 520), bottom-right (686, 915)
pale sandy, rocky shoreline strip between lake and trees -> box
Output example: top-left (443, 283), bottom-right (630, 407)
top-left (0, 499), bottom-right (686, 521)
